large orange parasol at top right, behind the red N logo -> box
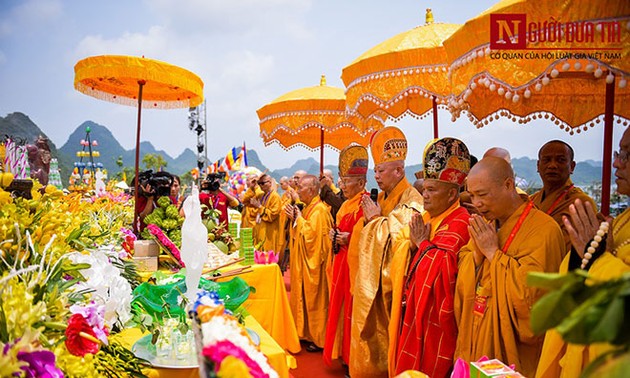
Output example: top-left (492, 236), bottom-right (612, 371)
top-left (444, 0), bottom-right (630, 214)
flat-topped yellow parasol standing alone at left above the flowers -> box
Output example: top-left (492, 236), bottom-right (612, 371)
top-left (74, 55), bottom-right (203, 232)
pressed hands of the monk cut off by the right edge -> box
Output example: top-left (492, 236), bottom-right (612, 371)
top-left (562, 199), bottom-right (612, 258)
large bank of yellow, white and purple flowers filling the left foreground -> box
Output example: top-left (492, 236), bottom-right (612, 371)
top-left (0, 182), bottom-right (147, 377)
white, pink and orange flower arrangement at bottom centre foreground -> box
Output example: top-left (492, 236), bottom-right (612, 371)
top-left (193, 291), bottom-right (278, 378)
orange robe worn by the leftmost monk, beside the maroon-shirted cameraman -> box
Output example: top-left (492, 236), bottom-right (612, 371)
top-left (254, 190), bottom-right (284, 252)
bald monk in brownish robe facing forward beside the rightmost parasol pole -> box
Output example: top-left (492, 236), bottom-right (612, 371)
top-left (531, 140), bottom-right (597, 253)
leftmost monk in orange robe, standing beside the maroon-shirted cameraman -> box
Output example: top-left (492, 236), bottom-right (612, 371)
top-left (250, 174), bottom-right (284, 252)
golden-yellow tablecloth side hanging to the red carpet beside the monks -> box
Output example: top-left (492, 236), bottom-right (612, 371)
top-left (218, 264), bottom-right (300, 354)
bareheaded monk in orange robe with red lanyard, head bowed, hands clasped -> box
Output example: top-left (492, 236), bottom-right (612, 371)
top-left (454, 157), bottom-right (564, 377)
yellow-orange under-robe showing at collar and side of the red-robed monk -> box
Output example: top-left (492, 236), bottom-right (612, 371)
top-left (387, 200), bottom-right (460, 376)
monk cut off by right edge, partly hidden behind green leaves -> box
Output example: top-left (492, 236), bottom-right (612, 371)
top-left (536, 129), bottom-right (630, 378)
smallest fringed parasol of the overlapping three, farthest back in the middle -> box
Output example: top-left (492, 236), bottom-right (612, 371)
top-left (257, 75), bottom-right (383, 173)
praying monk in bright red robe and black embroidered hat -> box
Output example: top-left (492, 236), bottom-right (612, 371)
top-left (389, 138), bottom-right (470, 378)
